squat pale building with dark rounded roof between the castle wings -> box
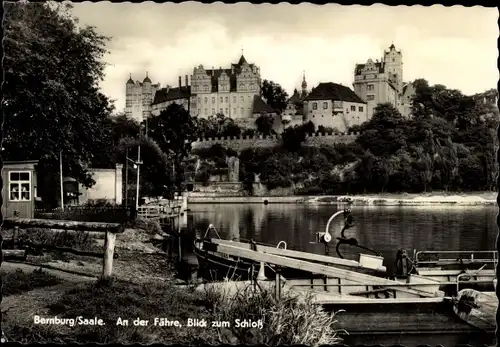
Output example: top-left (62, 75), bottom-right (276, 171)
top-left (304, 82), bottom-right (368, 132)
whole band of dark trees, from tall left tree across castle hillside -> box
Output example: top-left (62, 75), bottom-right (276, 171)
top-left (2, 3), bottom-right (499, 208)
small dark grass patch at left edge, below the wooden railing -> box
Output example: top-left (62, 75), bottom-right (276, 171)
top-left (0, 269), bottom-right (62, 297)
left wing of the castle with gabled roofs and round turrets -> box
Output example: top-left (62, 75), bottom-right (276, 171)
top-left (125, 55), bottom-right (275, 128)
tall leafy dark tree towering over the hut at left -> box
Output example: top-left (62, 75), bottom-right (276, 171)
top-left (2, 2), bottom-right (113, 204)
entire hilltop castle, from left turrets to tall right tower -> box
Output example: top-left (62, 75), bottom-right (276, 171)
top-left (125, 44), bottom-right (415, 126)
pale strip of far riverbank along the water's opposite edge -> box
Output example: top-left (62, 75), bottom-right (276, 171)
top-left (188, 192), bottom-right (498, 206)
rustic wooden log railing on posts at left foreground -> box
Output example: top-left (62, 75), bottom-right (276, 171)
top-left (2, 218), bottom-right (124, 279)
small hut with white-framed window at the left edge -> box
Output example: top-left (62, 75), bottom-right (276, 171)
top-left (2, 160), bottom-right (38, 218)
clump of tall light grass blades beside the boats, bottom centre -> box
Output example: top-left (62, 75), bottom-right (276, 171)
top-left (204, 285), bottom-right (341, 346)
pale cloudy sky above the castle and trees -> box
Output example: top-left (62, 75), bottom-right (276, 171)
top-left (73, 2), bottom-right (499, 112)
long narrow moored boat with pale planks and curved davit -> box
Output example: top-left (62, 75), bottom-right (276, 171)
top-left (193, 210), bottom-right (386, 280)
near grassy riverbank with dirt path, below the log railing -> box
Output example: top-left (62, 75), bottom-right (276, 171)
top-left (1, 229), bottom-right (341, 346)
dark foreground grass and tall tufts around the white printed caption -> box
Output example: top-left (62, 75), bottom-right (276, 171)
top-left (4, 280), bottom-right (346, 346)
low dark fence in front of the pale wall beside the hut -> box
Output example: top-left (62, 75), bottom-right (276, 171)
top-left (34, 206), bottom-right (135, 223)
